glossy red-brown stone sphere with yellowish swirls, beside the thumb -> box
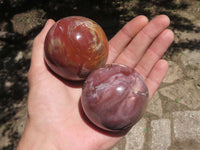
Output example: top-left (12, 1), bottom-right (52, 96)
top-left (44, 16), bottom-right (108, 80)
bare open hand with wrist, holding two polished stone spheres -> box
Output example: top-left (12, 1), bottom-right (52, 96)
top-left (17, 15), bottom-right (174, 150)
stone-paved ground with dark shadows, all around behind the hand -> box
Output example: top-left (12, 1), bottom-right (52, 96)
top-left (0, 0), bottom-right (200, 150)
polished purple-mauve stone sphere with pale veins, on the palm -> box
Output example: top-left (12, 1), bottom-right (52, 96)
top-left (81, 64), bottom-right (149, 131)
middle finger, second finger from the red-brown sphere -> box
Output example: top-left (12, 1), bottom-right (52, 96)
top-left (116, 15), bottom-right (170, 67)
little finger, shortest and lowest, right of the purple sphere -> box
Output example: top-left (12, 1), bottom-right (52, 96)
top-left (146, 60), bottom-right (168, 99)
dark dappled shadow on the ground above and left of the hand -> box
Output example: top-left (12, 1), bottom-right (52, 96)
top-left (0, 0), bottom-right (200, 150)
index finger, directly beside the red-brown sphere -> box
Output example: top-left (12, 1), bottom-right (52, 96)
top-left (108, 15), bottom-right (148, 63)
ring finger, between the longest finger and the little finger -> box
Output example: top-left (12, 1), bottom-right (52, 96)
top-left (135, 29), bottom-right (174, 78)
